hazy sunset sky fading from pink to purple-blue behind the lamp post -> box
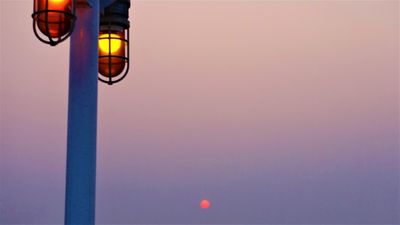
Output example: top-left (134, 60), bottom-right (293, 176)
top-left (0, 0), bottom-right (400, 224)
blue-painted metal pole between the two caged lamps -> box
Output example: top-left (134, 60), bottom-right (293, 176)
top-left (65, 0), bottom-right (100, 225)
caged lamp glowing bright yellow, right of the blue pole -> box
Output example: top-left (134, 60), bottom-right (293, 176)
top-left (99, 0), bottom-right (130, 85)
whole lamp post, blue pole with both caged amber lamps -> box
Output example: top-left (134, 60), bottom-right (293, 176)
top-left (32, 0), bottom-right (130, 225)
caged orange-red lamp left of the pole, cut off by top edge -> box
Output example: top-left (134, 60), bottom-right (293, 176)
top-left (32, 0), bottom-right (76, 46)
